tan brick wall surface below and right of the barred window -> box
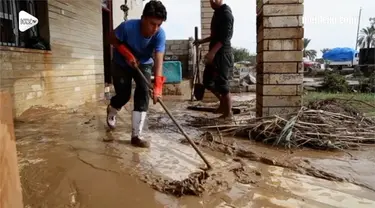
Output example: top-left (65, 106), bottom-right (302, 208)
top-left (0, 0), bottom-right (104, 116)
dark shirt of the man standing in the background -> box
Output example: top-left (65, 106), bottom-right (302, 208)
top-left (209, 4), bottom-right (234, 52)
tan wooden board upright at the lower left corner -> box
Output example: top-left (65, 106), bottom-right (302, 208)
top-left (0, 91), bottom-right (23, 208)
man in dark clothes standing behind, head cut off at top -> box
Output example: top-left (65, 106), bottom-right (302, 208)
top-left (195, 0), bottom-right (234, 118)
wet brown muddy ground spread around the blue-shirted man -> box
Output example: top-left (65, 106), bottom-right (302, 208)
top-left (15, 96), bottom-right (375, 208)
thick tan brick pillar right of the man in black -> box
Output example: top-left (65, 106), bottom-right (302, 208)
top-left (256, 0), bottom-right (304, 117)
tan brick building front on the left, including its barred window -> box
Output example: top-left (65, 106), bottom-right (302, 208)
top-left (0, 0), bottom-right (143, 116)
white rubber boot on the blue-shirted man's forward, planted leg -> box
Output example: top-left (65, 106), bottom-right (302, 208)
top-left (131, 111), bottom-right (150, 148)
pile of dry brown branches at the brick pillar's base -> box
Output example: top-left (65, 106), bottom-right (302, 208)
top-left (202, 100), bottom-right (375, 150)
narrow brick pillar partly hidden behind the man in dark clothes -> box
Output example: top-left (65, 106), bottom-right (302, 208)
top-left (201, 0), bottom-right (214, 54)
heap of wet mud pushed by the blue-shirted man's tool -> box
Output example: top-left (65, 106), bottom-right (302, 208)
top-left (141, 159), bottom-right (255, 197)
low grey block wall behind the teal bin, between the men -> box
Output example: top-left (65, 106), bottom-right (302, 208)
top-left (165, 38), bottom-right (194, 78)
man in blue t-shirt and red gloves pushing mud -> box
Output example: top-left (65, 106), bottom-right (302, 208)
top-left (107, 1), bottom-right (167, 147)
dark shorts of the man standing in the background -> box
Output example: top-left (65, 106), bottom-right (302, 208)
top-left (203, 52), bottom-right (234, 95)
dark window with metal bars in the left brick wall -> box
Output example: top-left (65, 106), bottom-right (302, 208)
top-left (0, 0), bottom-right (50, 50)
